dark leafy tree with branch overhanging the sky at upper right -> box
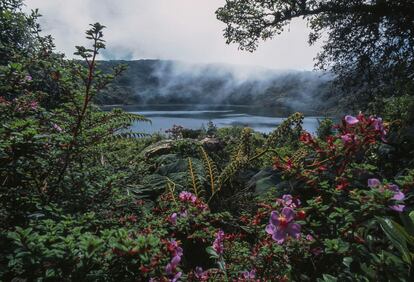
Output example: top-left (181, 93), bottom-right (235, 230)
top-left (216, 0), bottom-right (414, 110)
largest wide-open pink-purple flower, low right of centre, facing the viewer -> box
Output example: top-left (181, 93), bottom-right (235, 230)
top-left (266, 207), bottom-right (301, 244)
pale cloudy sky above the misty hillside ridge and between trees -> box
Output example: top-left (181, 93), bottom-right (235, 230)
top-left (25, 0), bottom-right (320, 70)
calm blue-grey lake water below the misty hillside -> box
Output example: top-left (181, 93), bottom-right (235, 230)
top-left (106, 105), bottom-right (322, 133)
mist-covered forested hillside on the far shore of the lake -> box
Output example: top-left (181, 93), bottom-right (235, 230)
top-left (96, 60), bottom-right (337, 111)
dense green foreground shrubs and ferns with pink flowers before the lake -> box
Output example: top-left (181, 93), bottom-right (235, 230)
top-left (0, 0), bottom-right (414, 281)
